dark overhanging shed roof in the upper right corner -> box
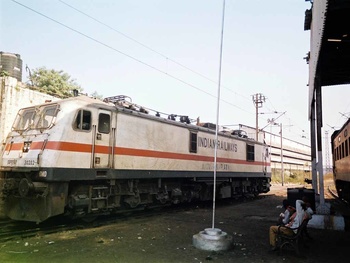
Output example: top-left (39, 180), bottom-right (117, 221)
top-left (304, 0), bottom-right (350, 116)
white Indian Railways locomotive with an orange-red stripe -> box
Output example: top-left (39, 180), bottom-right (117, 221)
top-left (1, 96), bottom-right (271, 222)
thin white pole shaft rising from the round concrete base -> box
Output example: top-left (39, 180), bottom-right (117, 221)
top-left (211, 0), bottom-right (225, 231)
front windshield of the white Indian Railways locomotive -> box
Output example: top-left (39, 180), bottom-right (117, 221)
top-left (12, 105), bottom-right (58, 132)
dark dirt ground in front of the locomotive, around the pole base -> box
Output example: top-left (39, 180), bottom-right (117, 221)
top-left (0, 185), bottom-right (350, 263)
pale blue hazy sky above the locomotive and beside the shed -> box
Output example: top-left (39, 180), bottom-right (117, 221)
top-left (0, 0), bottom-right (350, 145)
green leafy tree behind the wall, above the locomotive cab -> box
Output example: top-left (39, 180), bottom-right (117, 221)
top-left (29, 67), bottom-right (83, 98)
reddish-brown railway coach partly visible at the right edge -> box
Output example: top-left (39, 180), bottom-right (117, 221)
top-left (332, 119), bottom-right (350, 202)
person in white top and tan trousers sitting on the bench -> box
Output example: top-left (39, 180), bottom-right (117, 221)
top-left (269, 198), bottom-right (312, 251)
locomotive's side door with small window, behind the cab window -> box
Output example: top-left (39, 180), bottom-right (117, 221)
top-left (92, 109), bottom-right (113, 168)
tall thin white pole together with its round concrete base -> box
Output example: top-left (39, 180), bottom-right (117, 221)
top-left (193, 0), bottom-right (233, 251)
